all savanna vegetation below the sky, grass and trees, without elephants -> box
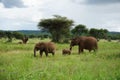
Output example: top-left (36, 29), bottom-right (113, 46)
top-left (0, 15), bottom-right (120, 80)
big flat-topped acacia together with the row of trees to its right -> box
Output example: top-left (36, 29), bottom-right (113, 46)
top-left (38, 15), bottom-right (120, 42)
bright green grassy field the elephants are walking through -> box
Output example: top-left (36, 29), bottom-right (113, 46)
top-left (0, 39), bottom-right (120, 80)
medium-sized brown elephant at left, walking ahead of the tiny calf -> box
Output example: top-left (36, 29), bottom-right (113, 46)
top-left (34, 42), bottom-right (55, 57)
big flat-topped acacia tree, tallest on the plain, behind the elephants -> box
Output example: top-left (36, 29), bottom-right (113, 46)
top-left (38, 15), bottom-right (73, 42)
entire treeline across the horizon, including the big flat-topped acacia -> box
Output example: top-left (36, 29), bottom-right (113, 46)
top-left (0, 15), bottom-right (120, 42)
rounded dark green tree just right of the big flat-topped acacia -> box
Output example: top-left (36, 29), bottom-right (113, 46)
top-left (71, 24), bottom-right (88, 36)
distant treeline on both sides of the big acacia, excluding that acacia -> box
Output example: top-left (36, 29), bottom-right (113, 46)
top-left (0, 28), bottom-right (120, 42)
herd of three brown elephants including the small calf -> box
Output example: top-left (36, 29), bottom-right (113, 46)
top-left (34, 36), bottom-right (98, 57)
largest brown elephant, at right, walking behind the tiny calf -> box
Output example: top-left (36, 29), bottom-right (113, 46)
top-left (70, 36), bottom-right (98, 54)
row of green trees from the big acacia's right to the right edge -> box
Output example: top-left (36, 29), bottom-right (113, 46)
top-left (71, 24), bottom-right (120, 41)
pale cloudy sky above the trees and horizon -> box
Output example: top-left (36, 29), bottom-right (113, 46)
top-left (0, 0), bottom-right (120, 32)
